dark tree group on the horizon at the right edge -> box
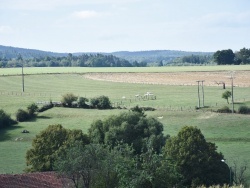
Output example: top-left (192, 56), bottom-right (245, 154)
top-left (213, 48), bottom-right (250, 65)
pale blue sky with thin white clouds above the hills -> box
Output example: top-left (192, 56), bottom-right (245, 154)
top-left (0, 0), bottom-right (250, 53)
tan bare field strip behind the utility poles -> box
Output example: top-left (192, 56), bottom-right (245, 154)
top-left (83, 71), bottom-right (250, 87)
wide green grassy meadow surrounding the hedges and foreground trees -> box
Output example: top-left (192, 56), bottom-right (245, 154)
top-left (0, 66), bottom-right (250, 182)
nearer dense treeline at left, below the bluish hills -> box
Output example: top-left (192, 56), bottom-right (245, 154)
top-left (0, 54), bottom-right (135, 68)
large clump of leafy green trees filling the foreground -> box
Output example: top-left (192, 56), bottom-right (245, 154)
top-left (26, 108), bottom-right (233, 187)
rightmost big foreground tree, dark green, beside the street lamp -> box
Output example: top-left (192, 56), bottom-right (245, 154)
top-left (165, 126), bottom-right (230, 187)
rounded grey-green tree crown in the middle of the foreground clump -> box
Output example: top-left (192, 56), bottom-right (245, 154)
top-left (89, 111), bottom-right (165, 154)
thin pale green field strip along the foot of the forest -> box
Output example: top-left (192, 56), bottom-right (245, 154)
top-left (0, 65), bottom-right (250, 75)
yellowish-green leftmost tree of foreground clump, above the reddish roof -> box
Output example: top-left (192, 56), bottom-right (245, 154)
top-left (26, 125), bottom-right (89, 172)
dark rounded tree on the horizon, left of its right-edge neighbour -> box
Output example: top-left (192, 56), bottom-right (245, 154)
top-left (214, 49), bottom-right (235, 65)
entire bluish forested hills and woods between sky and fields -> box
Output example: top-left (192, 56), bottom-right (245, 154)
top-left (0, 45), bottom-right (213, 67)
